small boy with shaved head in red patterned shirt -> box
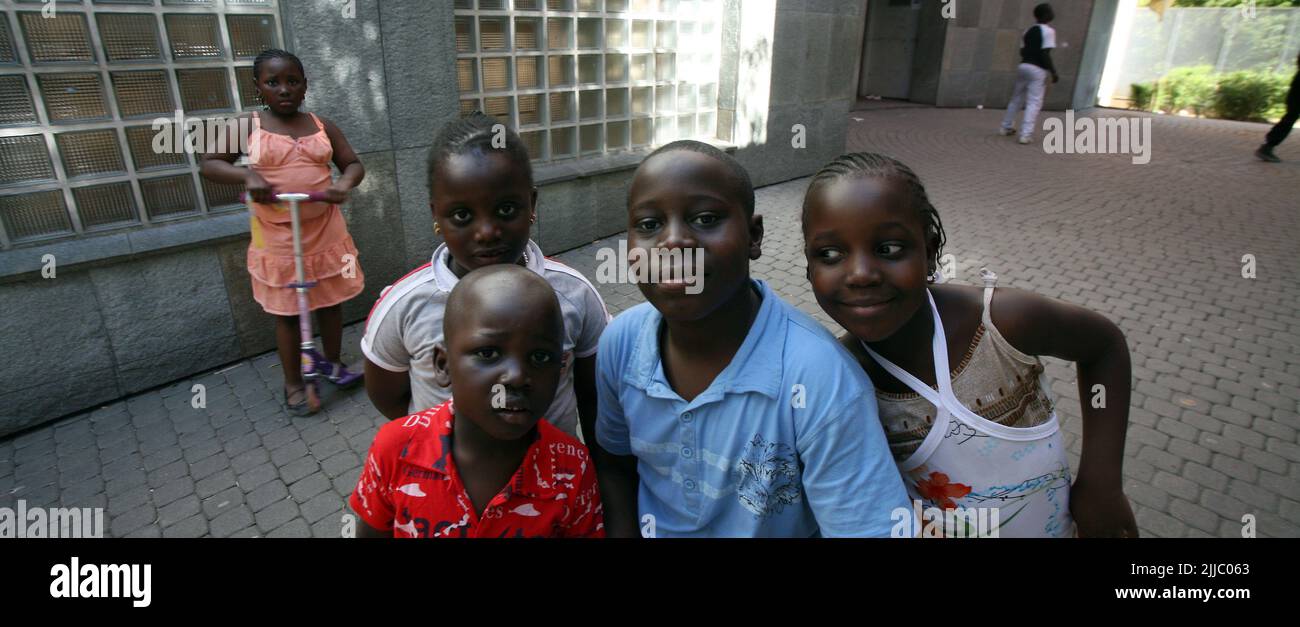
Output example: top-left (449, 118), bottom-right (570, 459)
top-left (348, 264), bottom-right (605, 537)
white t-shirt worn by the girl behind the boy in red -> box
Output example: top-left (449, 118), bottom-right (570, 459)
top-left (361, 239), bottom-right (610, 437)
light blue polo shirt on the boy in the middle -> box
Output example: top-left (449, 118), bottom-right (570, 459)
top-left (595, 280), bottom-right (911, 537)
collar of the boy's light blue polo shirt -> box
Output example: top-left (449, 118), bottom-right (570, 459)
top-left (623, 278), bottom-right (789, 405)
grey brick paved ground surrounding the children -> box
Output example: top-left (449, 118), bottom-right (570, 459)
top-left (0, 107), bottom-right (1300, 537)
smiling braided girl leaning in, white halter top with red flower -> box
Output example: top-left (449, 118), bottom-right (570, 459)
top-left (803, 152), bottom-right (1138, 537)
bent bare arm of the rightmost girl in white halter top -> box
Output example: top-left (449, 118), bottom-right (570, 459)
top-left (992, 289), bottom-right (1138, 537)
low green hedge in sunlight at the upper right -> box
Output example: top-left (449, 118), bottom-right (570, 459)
top-left (1132, 65), bottom-right (1291, 122)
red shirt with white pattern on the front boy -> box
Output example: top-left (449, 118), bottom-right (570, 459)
top-left (348, 401), bottom-right (605, 537)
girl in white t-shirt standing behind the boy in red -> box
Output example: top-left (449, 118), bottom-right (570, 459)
top-left (361, 112), bottom-right (610, 442)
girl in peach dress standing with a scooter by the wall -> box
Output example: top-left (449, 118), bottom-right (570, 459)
top-left (202, 49), bottom-right (365, 415)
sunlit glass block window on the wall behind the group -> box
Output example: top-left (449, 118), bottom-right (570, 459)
top-left (455, 0), bottom-right (723, 161)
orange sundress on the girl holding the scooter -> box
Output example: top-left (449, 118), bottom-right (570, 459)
top-left (248, 113), bottom-right (365, 316)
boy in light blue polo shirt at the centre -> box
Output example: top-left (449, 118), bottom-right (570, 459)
top-left (595, 140), bottom-right (910, 537)
